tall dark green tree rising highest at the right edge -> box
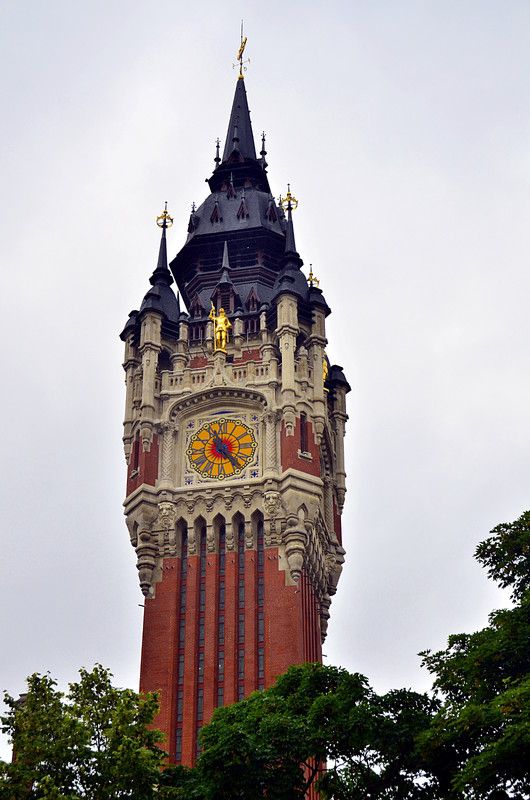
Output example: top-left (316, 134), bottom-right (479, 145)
top-left (419, 512), bottom-right (530, 800)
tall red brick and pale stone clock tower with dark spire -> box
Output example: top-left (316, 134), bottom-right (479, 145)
top-left (121, 61), bottom-right (350, 765)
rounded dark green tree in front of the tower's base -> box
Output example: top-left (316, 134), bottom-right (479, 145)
top-left (160, 664), bottom-right (437, 800)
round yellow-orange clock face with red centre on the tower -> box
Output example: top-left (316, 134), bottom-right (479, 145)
top-left (186, 418), bottom-right (257, 481)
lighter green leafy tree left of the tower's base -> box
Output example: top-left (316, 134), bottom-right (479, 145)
top-left (0, 665), bottom-right (165, 800)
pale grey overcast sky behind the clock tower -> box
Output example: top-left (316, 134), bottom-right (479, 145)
top-left (0, 0), bottom-right (530, 756)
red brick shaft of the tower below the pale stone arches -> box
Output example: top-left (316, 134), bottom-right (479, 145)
top-left (140, 548), bottom-right (322, 766)
